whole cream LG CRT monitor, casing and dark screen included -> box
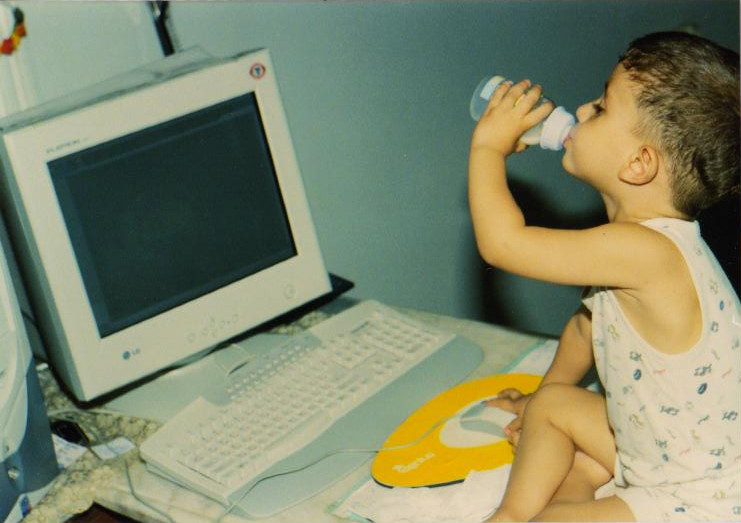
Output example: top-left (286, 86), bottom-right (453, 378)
top-left (0, 50), bottom-right (330, 401)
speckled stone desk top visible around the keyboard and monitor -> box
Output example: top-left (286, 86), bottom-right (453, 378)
top-left (28, 302), bottom-right (542, 523)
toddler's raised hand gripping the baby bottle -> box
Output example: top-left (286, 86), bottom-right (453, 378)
top-left (471, 80), bottom-right (553, 156)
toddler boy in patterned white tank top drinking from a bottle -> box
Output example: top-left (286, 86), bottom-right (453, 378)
top-left (469, 33), bottom-right (741, 521)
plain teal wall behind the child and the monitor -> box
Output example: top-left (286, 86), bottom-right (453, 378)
top-left (172, 0), bottom-right (739, 334)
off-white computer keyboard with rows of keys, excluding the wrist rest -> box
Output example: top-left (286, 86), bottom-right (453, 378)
top-left (140, 301), bottom-right (480, 516)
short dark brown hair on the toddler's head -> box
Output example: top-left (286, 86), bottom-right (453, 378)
top-left (619, 32), bottom-right (741, 217)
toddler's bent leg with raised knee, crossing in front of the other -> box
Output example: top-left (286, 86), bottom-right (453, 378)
top-left (492, 384), bottom-right (615, 521)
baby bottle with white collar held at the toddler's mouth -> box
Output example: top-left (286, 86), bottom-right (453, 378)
top-left (469, 76), bottom-right (575, 151)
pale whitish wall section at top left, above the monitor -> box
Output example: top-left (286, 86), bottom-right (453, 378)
top-left (0, 1), bottom-right (162, 116)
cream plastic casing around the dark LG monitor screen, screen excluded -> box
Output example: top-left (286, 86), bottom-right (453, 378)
top-left (1, 50), bottom-right (331, 401)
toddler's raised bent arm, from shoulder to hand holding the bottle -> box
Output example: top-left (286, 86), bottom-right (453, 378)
top-left (469, 81), bottom-right (678, 289)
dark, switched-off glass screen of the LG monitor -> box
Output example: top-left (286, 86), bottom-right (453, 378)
top-left (49, 93), bottom-right (296, 336)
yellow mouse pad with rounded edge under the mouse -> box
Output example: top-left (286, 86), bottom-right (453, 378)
top-left (371, 374), bottom-right (543, 487)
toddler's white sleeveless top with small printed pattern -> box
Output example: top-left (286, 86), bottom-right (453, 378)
top-left (584, 218), bottom-right (741, 491)
